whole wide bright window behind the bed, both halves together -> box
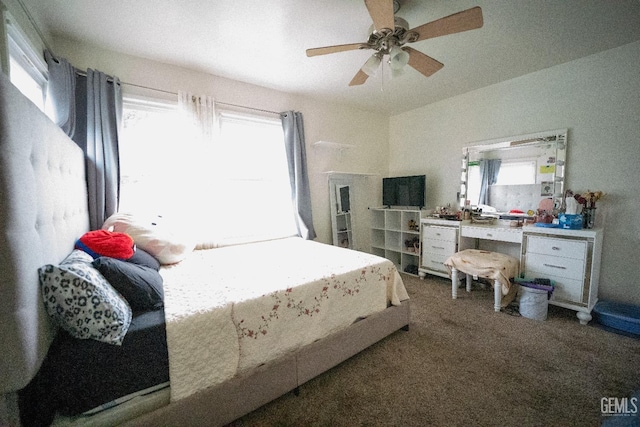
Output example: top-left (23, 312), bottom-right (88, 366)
top-left (120, 99), bottom-right (296, 244)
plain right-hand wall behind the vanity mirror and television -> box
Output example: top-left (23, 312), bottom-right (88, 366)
top-left (389, 42), bottom-right (640, 304)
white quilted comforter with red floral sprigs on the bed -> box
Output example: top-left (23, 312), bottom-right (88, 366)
top-left (161, 237), bottom-right (408, 401)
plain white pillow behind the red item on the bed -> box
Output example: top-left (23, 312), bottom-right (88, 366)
top-left (102, 213), bottom-right (195, 264)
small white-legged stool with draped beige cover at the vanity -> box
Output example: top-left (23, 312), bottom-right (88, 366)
top-left (444, 249), bottom-right (520, 311)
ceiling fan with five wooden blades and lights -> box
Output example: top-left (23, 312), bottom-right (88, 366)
top-left (307, 0), bottom-right (483, 86)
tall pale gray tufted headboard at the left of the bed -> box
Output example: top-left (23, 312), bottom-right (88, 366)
top-left (0, 72), bottom-right (89, 395)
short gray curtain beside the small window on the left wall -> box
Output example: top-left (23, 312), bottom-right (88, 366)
top-left (44, 50), bottom-right (76, 138)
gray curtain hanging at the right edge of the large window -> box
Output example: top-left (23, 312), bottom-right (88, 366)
top-left (280, 111), bottom-right (316, 240)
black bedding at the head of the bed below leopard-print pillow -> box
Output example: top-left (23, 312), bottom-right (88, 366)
top-left (18, 309), bottom-right (169, 426)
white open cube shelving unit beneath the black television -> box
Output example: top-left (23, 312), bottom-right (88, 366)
top-left (370, 208), bottom-right (422, 276)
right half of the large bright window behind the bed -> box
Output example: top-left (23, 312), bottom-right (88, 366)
top-left (212, 113), bottom-right (296, 244)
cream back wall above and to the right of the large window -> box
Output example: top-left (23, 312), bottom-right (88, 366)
top-left (48, 38), bottom-right (389, 251)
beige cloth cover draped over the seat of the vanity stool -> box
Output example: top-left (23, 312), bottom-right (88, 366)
top-left (444, 249), bottom-right (520, 295)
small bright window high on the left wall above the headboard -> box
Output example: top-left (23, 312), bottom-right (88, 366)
top-left (7, 18), bottom-right (48, 110)
